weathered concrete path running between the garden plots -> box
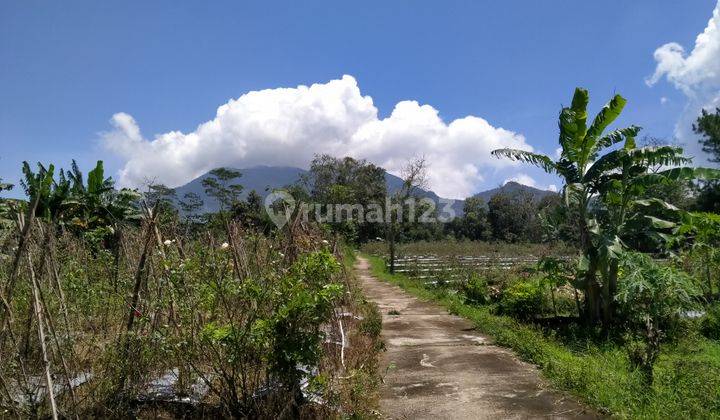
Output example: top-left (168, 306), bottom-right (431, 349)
top-left (355, 257), bottom-right (597, 420)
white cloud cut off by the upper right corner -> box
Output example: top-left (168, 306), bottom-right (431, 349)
top-left (646, 1), bottom-right (720, 164)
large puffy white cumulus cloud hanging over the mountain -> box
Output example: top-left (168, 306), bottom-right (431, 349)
top-left (101, 75), bottom-right (533, 198)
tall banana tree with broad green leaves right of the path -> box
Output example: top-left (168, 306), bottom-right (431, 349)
top-left (492, 88), bottom-right (718, 326)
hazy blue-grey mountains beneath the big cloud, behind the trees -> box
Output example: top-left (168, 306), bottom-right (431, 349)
top-left (175, 166), bottom-right (553, 216)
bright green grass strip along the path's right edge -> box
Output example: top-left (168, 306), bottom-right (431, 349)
top-left (364, 254), bottom-right (720, 419)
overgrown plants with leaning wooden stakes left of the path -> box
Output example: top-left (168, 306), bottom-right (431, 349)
top-left (0, 162), bottom-right (382, 418)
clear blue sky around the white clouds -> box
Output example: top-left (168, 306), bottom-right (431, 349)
top-left (0, 0), bottom-right (716, 199)
